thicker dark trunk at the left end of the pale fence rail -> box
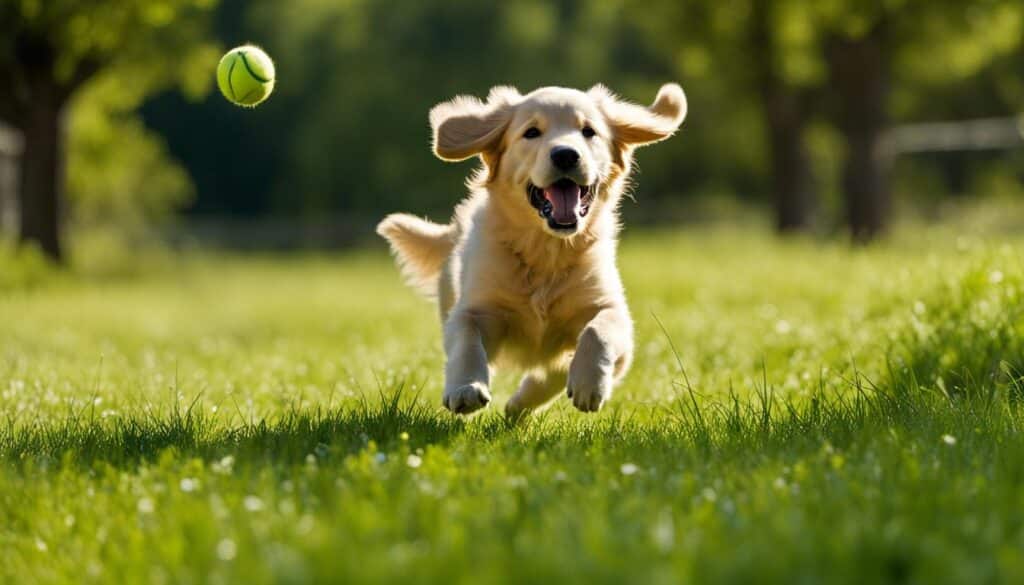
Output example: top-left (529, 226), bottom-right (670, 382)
top-left (827, 26), bottom-right (891, 243)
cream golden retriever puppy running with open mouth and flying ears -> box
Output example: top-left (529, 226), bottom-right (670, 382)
top-left (377, 84), bottom-right (687, 418)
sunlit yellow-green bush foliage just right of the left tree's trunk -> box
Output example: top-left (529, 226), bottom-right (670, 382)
top-left (67, 44), bottom-right (219, 260)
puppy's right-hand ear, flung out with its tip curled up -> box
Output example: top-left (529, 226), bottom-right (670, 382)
top-left (588, 83), bottom-right (686, 148)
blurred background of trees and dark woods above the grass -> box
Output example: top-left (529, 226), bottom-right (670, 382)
top-left (0, 0), bottom-right (1024, 262)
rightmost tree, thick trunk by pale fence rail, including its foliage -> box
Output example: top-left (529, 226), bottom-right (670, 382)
top-left (814, 0), bottom-right (1024, 242)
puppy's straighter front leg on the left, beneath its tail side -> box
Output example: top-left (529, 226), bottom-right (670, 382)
top-left (442, 309), bottom-right (498, 414)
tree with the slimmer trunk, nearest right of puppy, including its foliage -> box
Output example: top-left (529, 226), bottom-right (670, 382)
top-left (631, 0), bottom-right (818, 233)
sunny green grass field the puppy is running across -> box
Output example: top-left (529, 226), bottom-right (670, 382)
top-left (0, 229), bottom-right (1024, 585)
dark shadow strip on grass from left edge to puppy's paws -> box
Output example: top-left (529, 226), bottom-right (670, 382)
top-left (0, 387), bottom-right (466, 466)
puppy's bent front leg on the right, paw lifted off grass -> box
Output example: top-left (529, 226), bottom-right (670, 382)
top-left (566, 306), bottom-right (633, 412)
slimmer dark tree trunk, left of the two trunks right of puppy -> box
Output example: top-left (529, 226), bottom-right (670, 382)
top-left (751, 0), bottom-right (816, 234)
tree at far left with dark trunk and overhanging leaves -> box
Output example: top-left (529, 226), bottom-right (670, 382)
top-left (0, 0), bottom-right (214, 261)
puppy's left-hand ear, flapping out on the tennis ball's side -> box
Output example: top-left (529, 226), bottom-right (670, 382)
top-left (430, 86), bottom-right (520, 162)
